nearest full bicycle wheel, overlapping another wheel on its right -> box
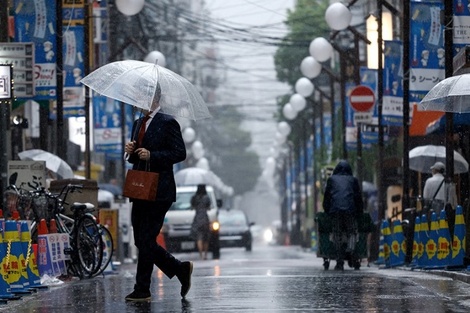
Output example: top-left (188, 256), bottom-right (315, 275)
top-left (74, 215), bottom-right (103, 277)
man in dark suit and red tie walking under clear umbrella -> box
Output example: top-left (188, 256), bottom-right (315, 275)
top-left (125, 98), bottom-right (193, 301)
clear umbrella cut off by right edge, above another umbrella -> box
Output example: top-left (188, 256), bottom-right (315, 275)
top-left (419, 74), bottom-right (470, 113)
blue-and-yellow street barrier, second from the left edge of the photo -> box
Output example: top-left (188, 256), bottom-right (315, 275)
top-left (5, 220), bottom-right (31, 294)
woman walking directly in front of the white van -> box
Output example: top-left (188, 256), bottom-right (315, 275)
top-left (191, 184), bottom-right (211, 260)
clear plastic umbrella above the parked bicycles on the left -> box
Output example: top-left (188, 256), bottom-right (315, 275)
top-left (18, 149), bottom-right (74, 179)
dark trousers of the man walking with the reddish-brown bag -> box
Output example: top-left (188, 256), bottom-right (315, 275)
top-left (131, 200), bottom-right (181, 290)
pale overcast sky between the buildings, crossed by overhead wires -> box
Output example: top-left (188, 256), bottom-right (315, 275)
top-left (206, 0), bottom-right (294, 168)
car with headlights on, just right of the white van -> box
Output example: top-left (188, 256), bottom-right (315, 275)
top-left (219, 210), bottom-right (255, 251)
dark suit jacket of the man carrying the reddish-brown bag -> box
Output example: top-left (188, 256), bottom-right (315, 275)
top-left (128, 112), bottom-right (186, 202)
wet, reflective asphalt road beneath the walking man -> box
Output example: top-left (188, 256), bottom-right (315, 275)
top-left (0, 245), bottom-right (470, 313)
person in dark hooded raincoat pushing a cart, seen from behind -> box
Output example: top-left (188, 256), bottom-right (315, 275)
top-left (323, 160), bottom-right (364, 270)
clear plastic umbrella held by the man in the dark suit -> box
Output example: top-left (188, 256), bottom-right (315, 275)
top-left (80, 60), bottom-right (211, 120)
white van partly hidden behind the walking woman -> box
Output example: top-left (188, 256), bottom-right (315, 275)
top-left (162, 185), bottom-right (221, 259)
